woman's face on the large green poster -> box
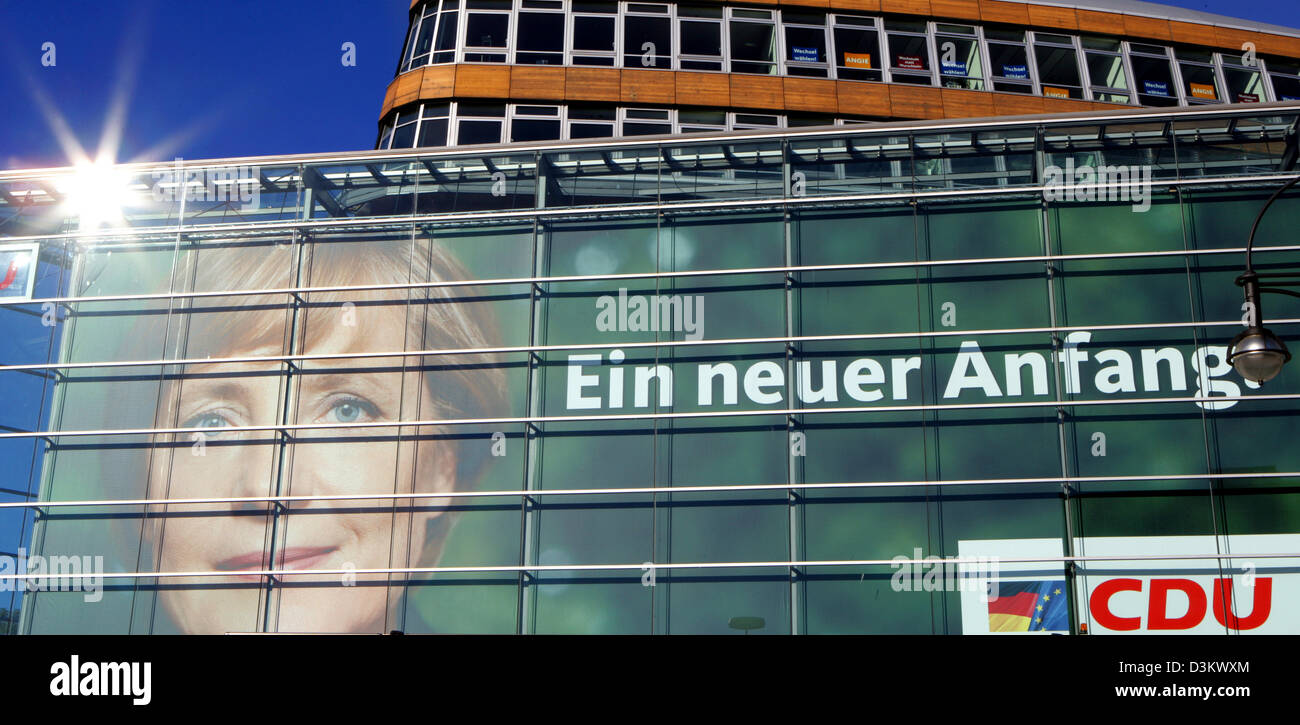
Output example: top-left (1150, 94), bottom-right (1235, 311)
top-left (150, 305), bottom-right (455, 633)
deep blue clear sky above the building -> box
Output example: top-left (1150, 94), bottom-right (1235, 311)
top-left (0, 0), bottom-right (1300, 169)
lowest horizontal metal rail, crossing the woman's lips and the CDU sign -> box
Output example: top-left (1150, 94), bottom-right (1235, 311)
top-left (10, 553), bottom-right (1300, 587)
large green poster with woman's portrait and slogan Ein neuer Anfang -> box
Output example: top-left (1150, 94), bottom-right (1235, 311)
top-left (15, 196), bottom-right (1300, 633)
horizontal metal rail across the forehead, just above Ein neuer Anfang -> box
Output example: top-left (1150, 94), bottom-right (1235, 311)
top-left (0, 317), bottom-right (1300, 374)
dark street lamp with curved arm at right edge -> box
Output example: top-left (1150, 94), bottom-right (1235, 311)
top-left (1227, 177), bottom-right (1300, 383)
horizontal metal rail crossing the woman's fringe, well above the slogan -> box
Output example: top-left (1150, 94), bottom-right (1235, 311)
top-left (0, 244), bottom-right (1300, 313)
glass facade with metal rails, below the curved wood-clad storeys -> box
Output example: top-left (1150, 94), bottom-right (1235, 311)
top-left (0, 103), bottom-right (1300, 634)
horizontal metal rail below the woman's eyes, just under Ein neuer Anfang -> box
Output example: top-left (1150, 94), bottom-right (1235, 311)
top-left (0, 392), bottom-right (1300, 439)
